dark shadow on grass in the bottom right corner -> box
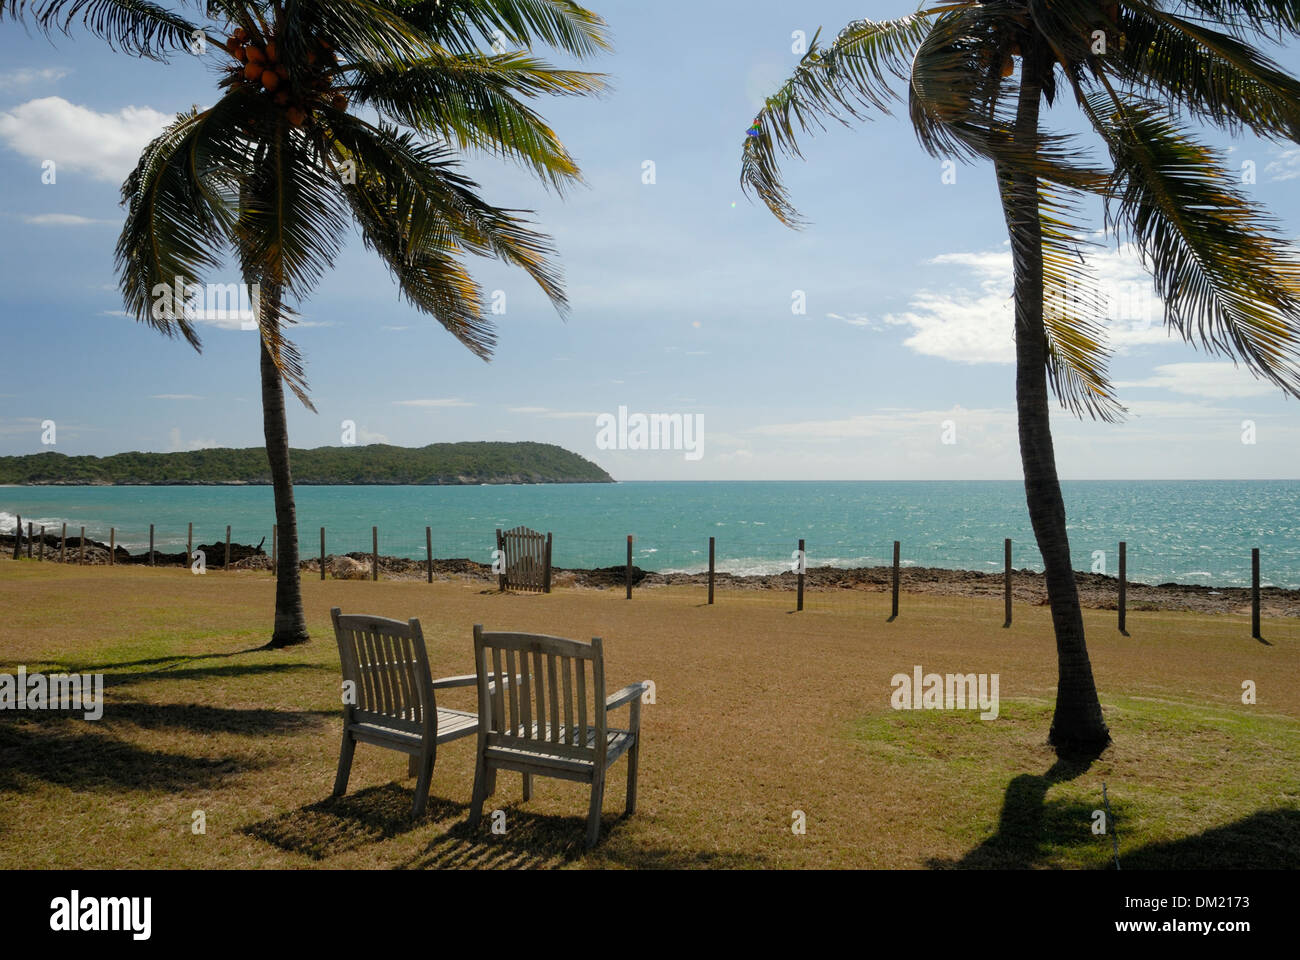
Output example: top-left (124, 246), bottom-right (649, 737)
top-left (1119, 809), bottom-right (1300, 870)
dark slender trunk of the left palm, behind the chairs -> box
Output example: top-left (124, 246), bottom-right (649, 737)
top-left (257, 285), bottom-right (311, 648)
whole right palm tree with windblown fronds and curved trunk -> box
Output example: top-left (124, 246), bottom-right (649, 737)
top-left (741, 0), bottom-right (1300, 756)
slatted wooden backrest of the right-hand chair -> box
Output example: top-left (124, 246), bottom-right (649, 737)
top-left (475, 624), bottom-right (606, 761)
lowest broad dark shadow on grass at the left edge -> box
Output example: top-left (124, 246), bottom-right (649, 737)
top-left (0, 714), bottom-right (254, 793)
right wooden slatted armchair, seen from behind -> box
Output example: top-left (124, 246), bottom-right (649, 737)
top-left (469, 624), bottom-right (650, 848)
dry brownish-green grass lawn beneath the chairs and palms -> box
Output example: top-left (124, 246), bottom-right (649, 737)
top-left (0, 559), bottom-right (1300, 869)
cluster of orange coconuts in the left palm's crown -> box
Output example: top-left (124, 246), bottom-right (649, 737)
top-left (225, 27), bottom-right (347, 126)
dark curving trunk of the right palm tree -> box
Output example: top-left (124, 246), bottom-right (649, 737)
top-left (997, 51), bottom-right (1110, 757)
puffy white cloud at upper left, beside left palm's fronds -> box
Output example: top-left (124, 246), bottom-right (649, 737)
top-left (0, 96), bottom-right (172, 183)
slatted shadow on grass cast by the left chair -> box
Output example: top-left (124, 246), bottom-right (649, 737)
top-left (241, 783), bottom-right (467, 860)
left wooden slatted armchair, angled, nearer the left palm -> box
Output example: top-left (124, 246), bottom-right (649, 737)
top-left (329, 606), bottom-right (495, 817)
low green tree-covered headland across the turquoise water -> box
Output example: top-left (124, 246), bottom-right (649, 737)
top-left (0, 442), bottom-right (614, 484)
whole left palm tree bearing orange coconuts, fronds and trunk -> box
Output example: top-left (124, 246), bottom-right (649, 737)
top-left (0, 0), bottom-right (608, 647)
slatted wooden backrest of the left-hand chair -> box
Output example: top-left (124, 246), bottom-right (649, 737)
top-left (329, 606), bottom-right (438, 735)
